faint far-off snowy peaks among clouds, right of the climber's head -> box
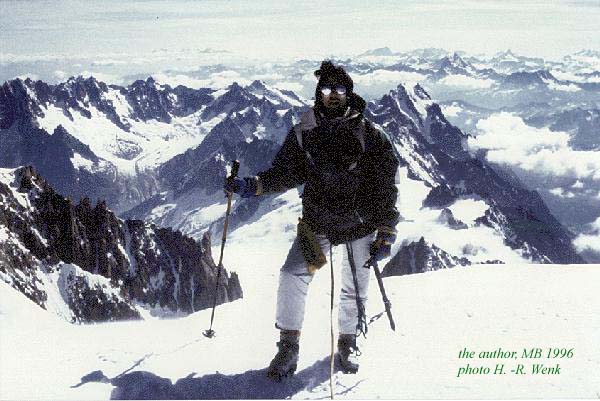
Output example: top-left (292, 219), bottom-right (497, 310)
top-left (346, 49), bottom-right (600, 109)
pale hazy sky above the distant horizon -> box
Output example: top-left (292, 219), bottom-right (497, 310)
top-left (0, 0), bottom-right (600, 62)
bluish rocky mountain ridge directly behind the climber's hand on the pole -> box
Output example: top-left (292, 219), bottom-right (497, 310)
top-left (124, 81), bottom-right (306, 237)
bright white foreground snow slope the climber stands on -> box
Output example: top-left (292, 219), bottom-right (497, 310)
top-left (0, 191), bottom-right (600, 400)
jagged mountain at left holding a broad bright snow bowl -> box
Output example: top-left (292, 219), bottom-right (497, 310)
top-left (0, 77), bottom-right (303, 213)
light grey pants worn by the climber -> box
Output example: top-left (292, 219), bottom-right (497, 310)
top-left (276, 233), bottom-right (375, 334)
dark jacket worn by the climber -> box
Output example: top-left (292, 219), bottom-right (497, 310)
top-left (258, 94), bottom-right (399, 244)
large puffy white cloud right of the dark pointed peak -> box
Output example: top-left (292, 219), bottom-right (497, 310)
top-left (468, 112), bottom-right (600, 182)
